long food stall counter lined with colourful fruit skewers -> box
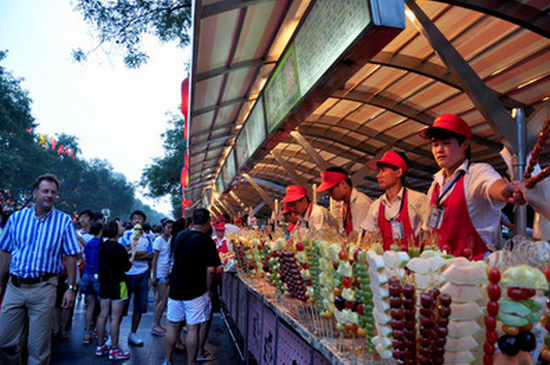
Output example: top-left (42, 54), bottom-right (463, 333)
top-left (221, 232), bottom-right (550, 365)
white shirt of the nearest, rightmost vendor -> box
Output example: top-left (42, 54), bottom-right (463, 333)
top-left (430, 160), bottom-right (506, 250)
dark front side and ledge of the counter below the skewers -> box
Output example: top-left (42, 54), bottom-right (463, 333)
top-left (221, 273), bottom-right (384, 365)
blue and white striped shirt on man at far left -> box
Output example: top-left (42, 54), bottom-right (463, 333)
top-left (0, 208), bottom-right (80, 278)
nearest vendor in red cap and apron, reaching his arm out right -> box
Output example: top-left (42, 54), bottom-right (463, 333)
top-left (419, 114), bottom-right (525, 260)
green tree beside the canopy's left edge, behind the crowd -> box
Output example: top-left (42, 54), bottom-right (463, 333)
top-left (141, 115), bottom-right (187, 217)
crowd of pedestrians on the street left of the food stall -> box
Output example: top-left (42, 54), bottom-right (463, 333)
top-left (0, 174), bottom-right (238, 365)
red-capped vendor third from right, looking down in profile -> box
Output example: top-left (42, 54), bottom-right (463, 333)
top-left (315, 167), bottom-right (372, 235)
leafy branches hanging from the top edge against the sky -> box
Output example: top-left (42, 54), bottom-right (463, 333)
top-left (73, 0), bottom-right (191, 68)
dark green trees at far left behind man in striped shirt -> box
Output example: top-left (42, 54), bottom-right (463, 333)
top-left (0, 51), bottom-right (138, 216)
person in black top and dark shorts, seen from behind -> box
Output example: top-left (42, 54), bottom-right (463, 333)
top-left (95, 219), bottom-right (137, 360)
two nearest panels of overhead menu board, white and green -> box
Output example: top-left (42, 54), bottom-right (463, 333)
top-left (264, 0), bottom-right (371, 133)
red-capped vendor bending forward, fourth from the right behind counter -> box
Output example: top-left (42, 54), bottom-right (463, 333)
top-left (282, 185), bottom-right (338, 231)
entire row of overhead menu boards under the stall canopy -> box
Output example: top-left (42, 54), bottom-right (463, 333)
top-left (216, 0), bottom-right (380, 187)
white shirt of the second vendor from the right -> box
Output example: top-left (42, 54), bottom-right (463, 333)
top-left (362, 188), bottom-right (430, 238)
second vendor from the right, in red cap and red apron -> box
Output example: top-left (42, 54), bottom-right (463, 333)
top-left (362, 151), bottom-right (429, 251)
